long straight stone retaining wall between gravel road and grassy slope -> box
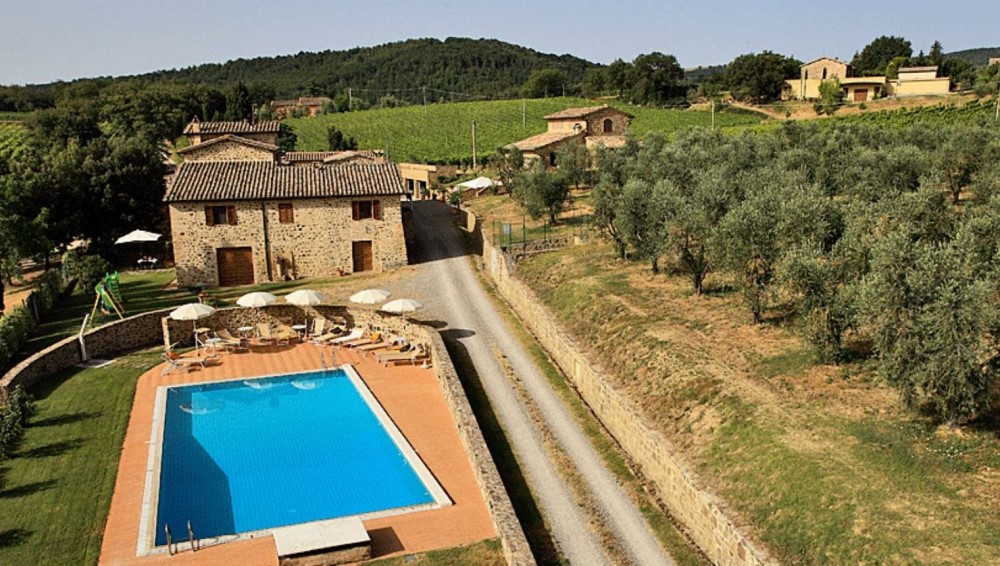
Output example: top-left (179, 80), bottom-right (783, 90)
top-left (463, 213), bottom-right (775, 566)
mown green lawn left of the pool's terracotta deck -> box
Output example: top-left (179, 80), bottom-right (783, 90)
top-left (0, 351), bottom-right (159, 565)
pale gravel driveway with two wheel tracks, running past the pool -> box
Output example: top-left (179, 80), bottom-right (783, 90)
top-left (400, 201), bottom-right (673, 564)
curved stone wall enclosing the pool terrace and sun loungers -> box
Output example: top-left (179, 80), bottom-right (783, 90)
top-left (0, 304), bottom-right (535, 566)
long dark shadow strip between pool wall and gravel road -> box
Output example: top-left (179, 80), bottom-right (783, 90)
top-left (441, 329), bottom-right (561, 564)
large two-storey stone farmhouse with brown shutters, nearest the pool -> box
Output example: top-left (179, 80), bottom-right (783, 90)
top-left (164, 122), bottom-right (407, 287)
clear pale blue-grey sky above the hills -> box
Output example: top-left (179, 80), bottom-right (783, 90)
top-left (0, 0), bottom-right (1000, 85)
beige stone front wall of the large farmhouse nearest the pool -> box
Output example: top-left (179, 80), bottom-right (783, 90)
top-left (169, 196), bottom-right (407, 287)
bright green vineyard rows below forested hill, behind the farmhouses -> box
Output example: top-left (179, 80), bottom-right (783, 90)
top-left (287, 98), bottom-right (763, 163)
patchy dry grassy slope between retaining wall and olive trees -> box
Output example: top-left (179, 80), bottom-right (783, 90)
top-left (519, 244), bottom-right (1000, 563)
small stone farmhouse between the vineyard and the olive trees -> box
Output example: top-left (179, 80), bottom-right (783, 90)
top-left (513, 105), bottom-right (633, 167)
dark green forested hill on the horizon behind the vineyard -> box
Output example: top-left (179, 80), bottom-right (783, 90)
top-left (0, 38), bottom-right (597, 111)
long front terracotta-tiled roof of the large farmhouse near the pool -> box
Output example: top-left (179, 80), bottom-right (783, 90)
top-left (163, 161), bottom-right (406, 202)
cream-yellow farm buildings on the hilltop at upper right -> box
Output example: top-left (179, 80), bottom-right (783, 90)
top-left (782, 57), bottom-right (950, 102)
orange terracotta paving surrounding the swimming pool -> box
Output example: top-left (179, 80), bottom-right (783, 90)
top-left (99, 344), bottom-right (497, 565)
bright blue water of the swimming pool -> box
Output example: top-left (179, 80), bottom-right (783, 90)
top-left (156, 370), bottom-right (434, 545)
